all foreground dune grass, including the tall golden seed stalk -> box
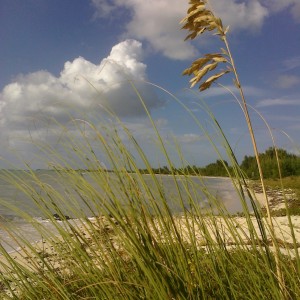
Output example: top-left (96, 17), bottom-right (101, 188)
top-left (0, 0), bottom-right (300, 300)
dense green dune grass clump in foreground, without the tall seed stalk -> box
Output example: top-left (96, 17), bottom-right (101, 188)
top-left (0, 144), bottom-right (300, 299)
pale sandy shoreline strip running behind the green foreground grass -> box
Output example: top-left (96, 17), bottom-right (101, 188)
top-left (0, 212), bottom-right (300, 296)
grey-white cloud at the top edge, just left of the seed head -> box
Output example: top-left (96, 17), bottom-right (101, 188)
top-left (92, 0), bottom-right (197, 60)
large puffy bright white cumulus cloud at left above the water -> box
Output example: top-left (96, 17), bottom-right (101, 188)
top-left (0, 40), bottom-right (162, 164)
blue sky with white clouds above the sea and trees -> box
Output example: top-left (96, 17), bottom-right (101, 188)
top-left (0, 0), bottom-right (300, 168)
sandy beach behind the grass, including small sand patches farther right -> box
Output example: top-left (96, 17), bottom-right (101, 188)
top-left (0, 183), bottom-right (300, 294)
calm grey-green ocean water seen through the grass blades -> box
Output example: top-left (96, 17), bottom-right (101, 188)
top-left (0, 170), bottom-right (249, 252)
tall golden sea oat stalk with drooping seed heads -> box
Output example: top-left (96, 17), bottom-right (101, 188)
top-left (182, 0), bottom-right (299, 298)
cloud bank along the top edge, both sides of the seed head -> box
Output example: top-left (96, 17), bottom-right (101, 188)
top-left (91, 0), bottom-right (300, 60)
